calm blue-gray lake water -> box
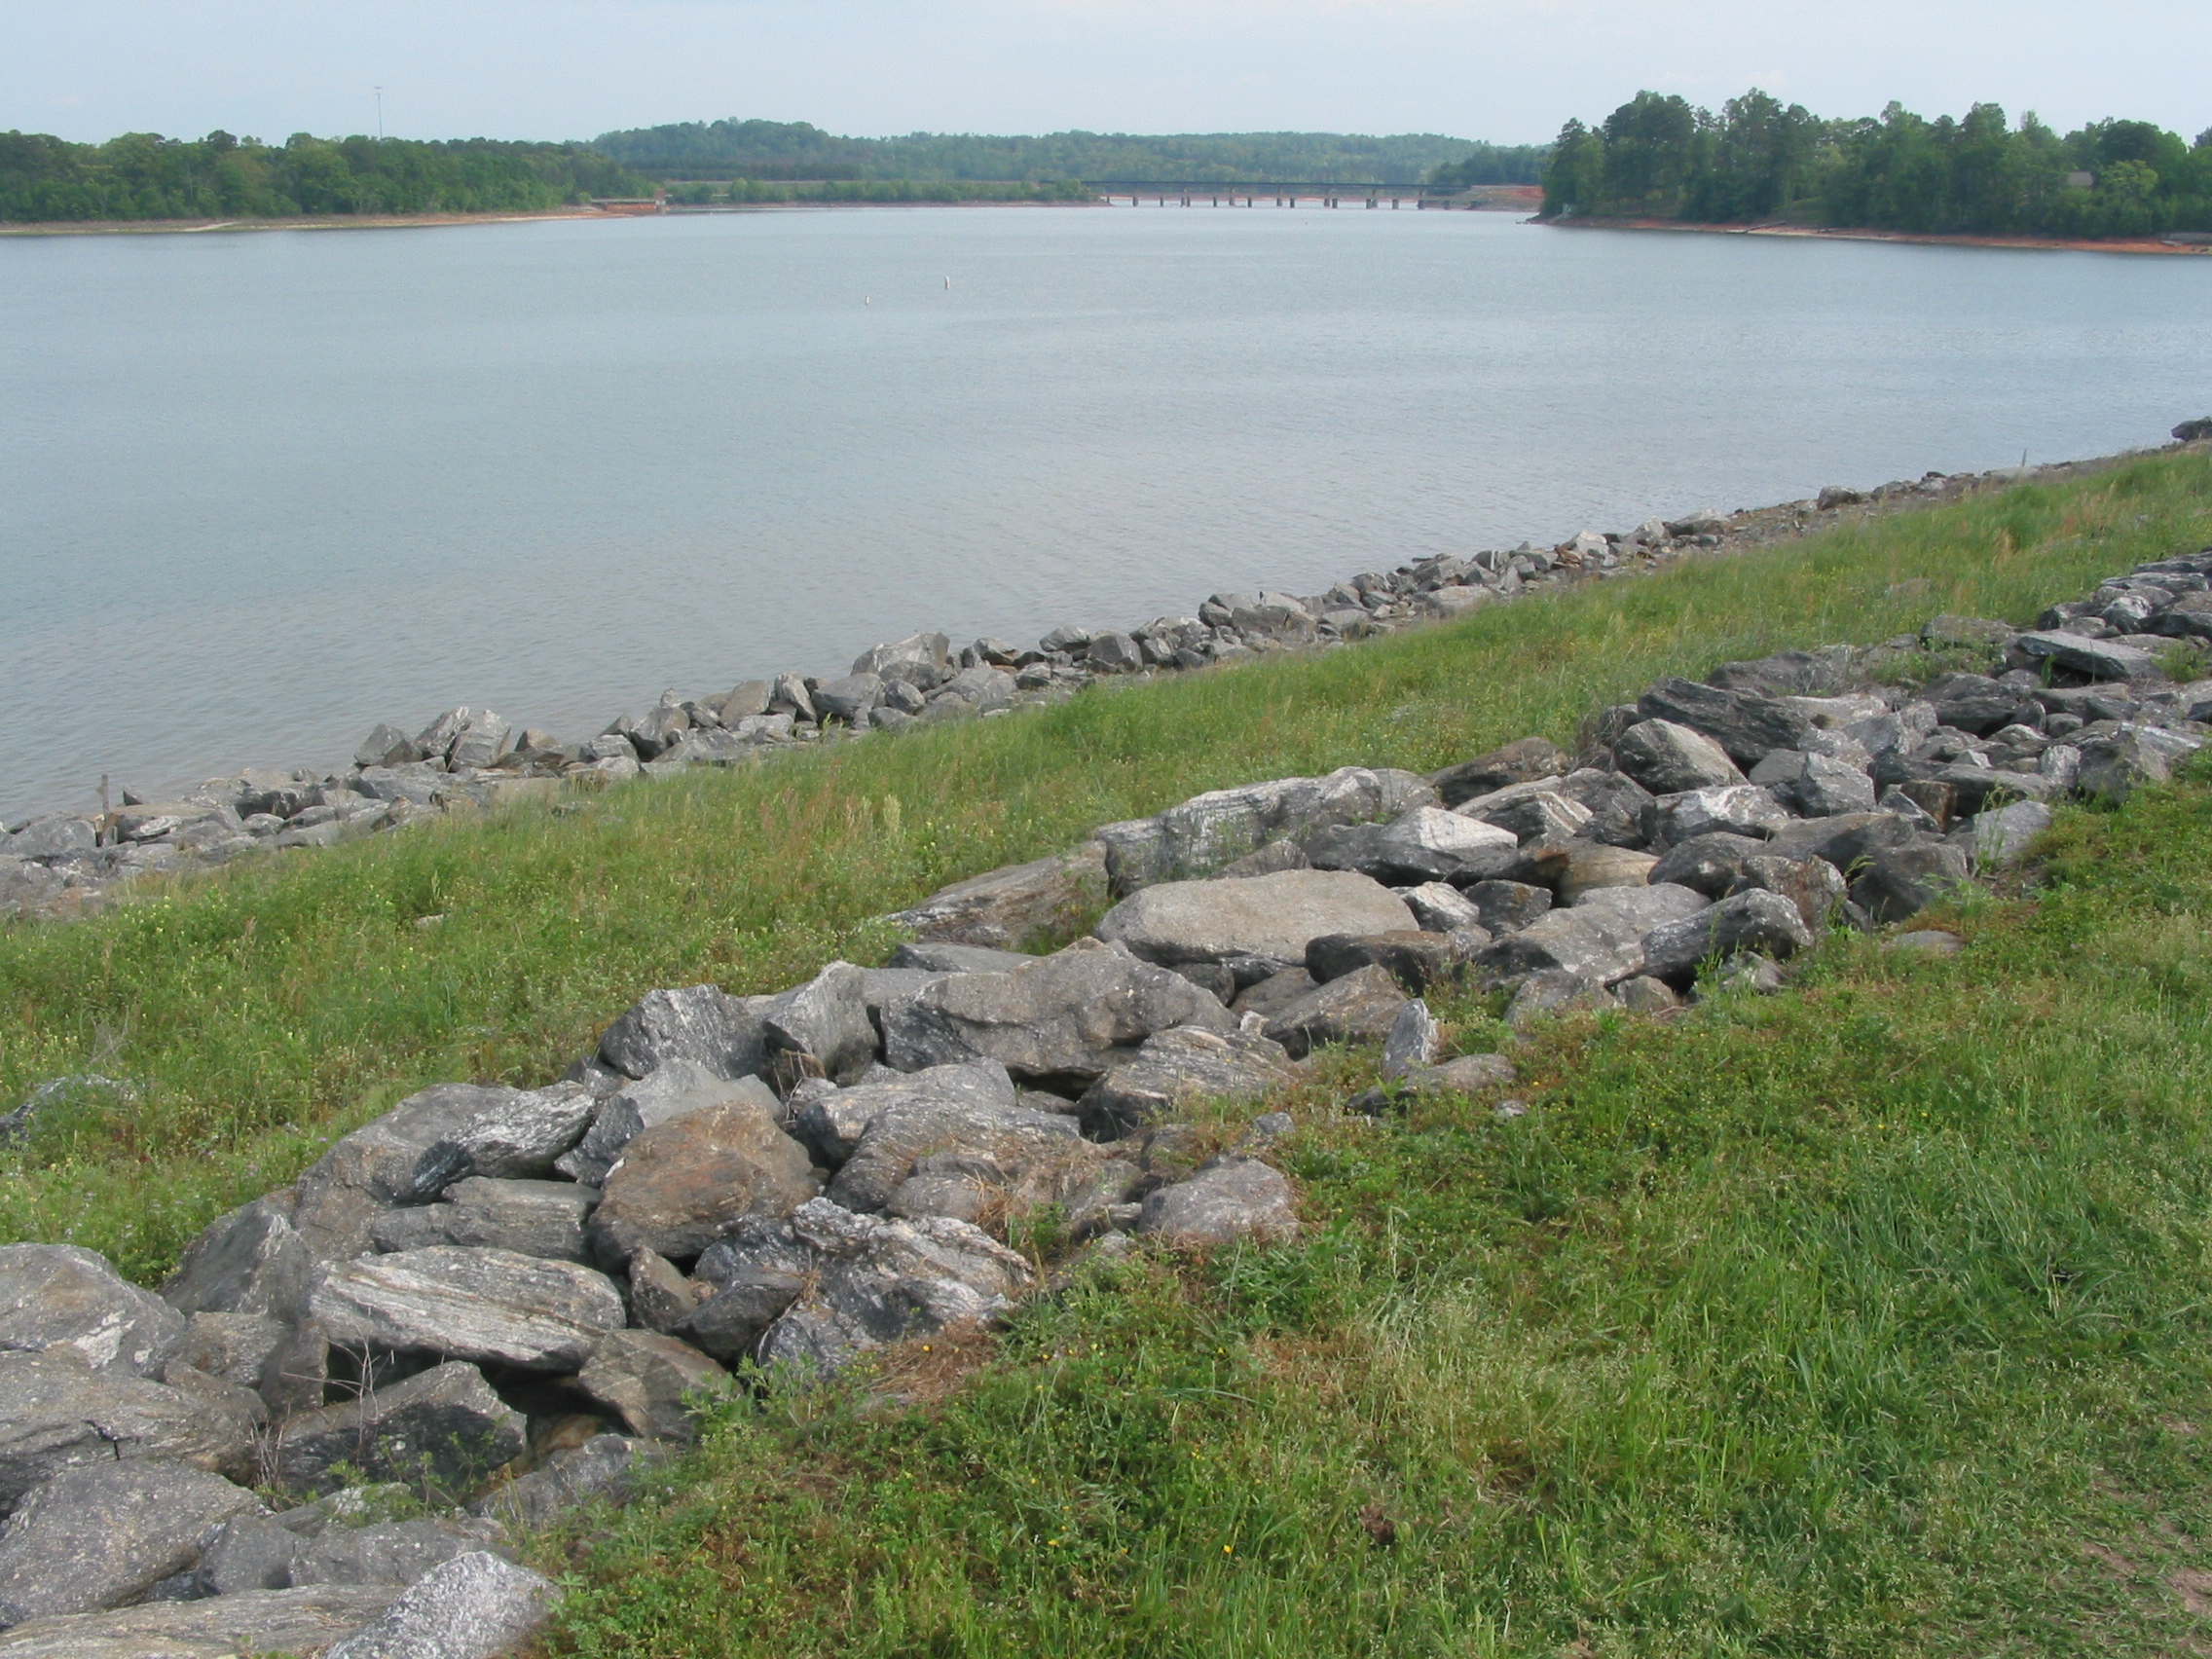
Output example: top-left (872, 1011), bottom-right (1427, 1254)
top-left (0, 205), bottom-right (2212, 819)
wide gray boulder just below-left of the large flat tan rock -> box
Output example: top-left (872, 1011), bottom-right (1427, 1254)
top-left (883, 941), bottom-right (1230, 1084)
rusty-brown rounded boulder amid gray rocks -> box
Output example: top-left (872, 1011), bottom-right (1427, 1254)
top-left (591, 1101), bottom-right (819, 1268)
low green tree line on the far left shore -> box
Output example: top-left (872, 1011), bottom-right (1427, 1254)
top-left (0, 132), bottom-right (652, 221)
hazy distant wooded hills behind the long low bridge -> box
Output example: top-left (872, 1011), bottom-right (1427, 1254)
top-left (595, 120), bottom-right (1544, 184)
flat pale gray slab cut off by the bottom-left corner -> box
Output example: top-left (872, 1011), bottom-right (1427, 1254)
top-left (0, 1584), bottom-right (396, 1659)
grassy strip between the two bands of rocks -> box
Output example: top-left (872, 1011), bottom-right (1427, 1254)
top-left (0, 454), bottom-right (2212, 1280)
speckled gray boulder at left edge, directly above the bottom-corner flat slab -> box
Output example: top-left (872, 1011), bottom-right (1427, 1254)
top-left (0, 1460), bottom-right (266, 1628)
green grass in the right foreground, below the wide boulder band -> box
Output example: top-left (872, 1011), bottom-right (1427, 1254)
top-left (551, 781), bottom-right (2212, 1659)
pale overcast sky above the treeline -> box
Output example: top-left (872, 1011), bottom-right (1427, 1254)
top-left (0, 0), bottom-right (2212, 144)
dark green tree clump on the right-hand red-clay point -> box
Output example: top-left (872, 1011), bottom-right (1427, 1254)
top-left (1544, 89), bottom-right (2212, 237)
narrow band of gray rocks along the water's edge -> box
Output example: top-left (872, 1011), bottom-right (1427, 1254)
top-left (0, 449), bottom-right (2176, 918)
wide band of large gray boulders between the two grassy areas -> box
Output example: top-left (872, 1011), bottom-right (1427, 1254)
top-left (0, 513), bottom-right (2212, 1659)
